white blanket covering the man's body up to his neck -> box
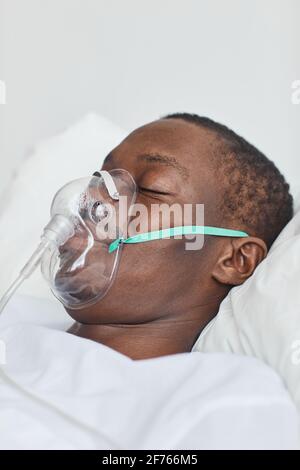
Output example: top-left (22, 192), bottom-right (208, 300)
top-left (0, 297), bottom-right (298, 449)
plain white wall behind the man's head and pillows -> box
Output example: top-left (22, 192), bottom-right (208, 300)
top-left (0, 0), bottom-right (300, 195)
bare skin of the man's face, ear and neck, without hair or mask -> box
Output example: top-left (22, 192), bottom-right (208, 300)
top-left (67, 119), bottom-right (267, 359)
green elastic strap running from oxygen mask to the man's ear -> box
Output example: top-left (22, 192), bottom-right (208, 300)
top-left (108, 225), bottom-right (249, 253)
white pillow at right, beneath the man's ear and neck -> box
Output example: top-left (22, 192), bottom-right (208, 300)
top-left (192, 200), bottom-right (300, 410)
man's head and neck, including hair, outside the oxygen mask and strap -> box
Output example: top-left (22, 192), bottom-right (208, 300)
top-left (67, 113), bottom-right (293, 359)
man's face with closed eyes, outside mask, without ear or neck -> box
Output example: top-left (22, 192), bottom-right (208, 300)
top-left (64, 119), bottom-right (224, 324)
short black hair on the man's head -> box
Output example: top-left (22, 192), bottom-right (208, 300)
top-left (161, 113), bottom-right (293, 248)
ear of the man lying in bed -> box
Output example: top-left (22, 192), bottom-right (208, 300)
top-left (212, 237), bottom-right (268, 286)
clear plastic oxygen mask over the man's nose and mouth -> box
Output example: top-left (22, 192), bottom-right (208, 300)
top-left (42, 169), bottom-right (136, 309)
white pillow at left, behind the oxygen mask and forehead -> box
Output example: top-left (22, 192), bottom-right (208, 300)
top-left (0, 114), bottom-right (126, 299)
